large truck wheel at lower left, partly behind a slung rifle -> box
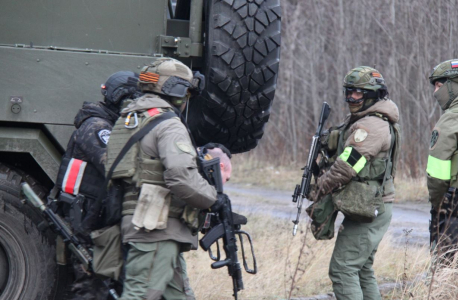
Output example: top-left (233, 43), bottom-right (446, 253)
top-left (0, 164), bottom-right (68, 300)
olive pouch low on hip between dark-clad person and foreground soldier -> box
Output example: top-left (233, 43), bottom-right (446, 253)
top-left (91, 224), bottom-right (123, 280)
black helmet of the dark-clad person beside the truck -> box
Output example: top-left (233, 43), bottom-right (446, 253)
top-left (101, 71), bottom-right (138, 108)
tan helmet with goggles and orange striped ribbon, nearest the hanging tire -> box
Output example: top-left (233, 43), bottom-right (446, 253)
top-left (139, 58), bottom-right (204, 105)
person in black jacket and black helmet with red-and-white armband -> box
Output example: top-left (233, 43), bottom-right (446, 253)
top-left (54, 71), bottom-right (140, 300)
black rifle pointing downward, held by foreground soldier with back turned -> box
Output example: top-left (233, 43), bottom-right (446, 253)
top-left (198, 152), bottom-right (258, 299)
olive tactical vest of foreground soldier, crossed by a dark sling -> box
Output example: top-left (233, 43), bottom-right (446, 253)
top-left (106, 108), bottom-right (183, 218)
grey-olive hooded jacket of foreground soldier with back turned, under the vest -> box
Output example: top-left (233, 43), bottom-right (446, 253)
top-left (121, 94), bottom-right (216, 249)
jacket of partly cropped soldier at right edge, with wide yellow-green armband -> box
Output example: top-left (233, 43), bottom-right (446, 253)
top-left (426, 98), bottom-right (458, 209)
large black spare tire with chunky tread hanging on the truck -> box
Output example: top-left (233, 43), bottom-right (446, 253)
top-left (189, 0), bottom-right (281, 153)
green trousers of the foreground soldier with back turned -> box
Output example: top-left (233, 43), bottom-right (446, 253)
top-left (120, 241), bottom-right (195, 300)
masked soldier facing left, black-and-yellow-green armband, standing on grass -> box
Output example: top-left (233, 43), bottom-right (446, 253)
top-left (315, 66), bottom-right (399, 300)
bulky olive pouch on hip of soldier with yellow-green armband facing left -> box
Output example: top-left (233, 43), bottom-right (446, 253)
top-left (332, 180), bottom-right (385, 223)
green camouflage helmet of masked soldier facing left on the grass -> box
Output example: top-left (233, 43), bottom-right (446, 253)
top-left (343, 66), bottom-right (388, 111)
